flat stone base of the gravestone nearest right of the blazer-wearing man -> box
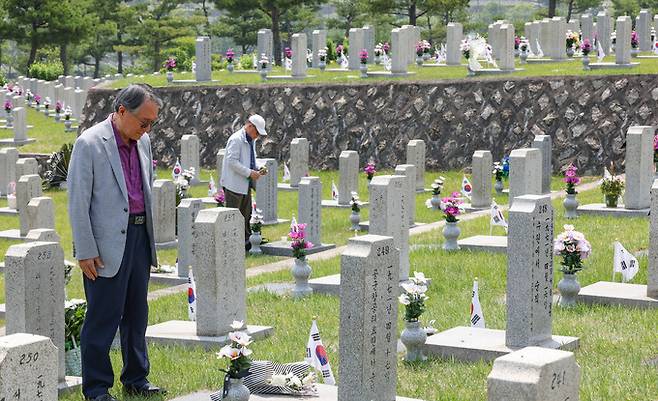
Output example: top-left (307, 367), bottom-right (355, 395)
top-left (146, 320), bottom-right (274, 348)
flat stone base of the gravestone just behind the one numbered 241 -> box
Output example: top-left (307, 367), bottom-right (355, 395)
top-left (423, 326), bottom-right (580, 362)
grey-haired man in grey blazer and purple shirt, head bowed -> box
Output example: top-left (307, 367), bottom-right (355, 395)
top-left (67, 85), bottom-right (163, 401)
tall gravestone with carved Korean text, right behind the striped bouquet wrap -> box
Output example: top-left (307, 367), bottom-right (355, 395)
top-left (338, 234), bottom-right (400, 401)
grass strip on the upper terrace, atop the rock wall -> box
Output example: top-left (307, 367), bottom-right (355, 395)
top-left (108, 53), bottom-right (658, 88)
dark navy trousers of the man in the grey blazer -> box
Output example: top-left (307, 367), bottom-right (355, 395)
top-left (80, 224), bottom-right (151, 398)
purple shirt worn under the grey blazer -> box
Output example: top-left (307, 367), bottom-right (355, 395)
top-left (110, 115), bottom-right (146, 214)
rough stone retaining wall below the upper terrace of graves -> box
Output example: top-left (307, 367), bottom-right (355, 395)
top-left (81, 75), bottom-right (658, 174)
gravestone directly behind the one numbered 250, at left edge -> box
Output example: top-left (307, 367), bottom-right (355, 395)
top-left (5, 242), bottom-right (65, 382)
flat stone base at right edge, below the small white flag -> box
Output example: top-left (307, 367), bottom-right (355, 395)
top-left (578, 281), bottom-right (658, 309)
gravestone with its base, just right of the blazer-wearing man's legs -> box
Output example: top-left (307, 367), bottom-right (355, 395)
top-left (146, 207), bottom-right (272, 346)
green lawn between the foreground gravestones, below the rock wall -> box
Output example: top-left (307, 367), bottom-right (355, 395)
top-left (52, 182), bottom-right (658, 401)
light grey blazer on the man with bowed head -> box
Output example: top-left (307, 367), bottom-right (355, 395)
top-left (67, 117), bottom-right (157, 277)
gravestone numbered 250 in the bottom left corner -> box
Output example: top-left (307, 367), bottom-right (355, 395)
top-left (0, 333), bottom-right (58, 401)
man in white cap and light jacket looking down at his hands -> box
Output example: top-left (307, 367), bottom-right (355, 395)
top-left (219, 114), bottom-right (267, 250)
